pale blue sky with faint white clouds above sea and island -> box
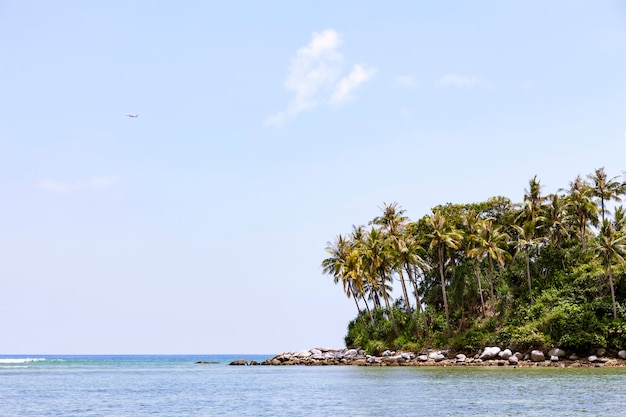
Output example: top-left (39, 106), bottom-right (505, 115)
top-left (0, 0), bottom-right (626, 354)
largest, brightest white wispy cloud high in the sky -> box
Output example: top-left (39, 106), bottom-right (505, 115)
top-left (265, 29), bottom-right (373, 126)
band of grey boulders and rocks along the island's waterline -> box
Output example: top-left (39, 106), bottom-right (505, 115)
top-left (230, 346), bottom-right (626, 368)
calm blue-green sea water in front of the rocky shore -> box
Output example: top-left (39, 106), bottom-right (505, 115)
top-left (0, 355), bottom-right (626, 417)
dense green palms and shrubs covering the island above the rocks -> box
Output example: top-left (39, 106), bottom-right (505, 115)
top-left (322, 168), bottom-right (626, 354)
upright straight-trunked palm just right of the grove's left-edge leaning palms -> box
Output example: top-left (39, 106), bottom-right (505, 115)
top-left (426, 211), bottom-right (463, 337)
